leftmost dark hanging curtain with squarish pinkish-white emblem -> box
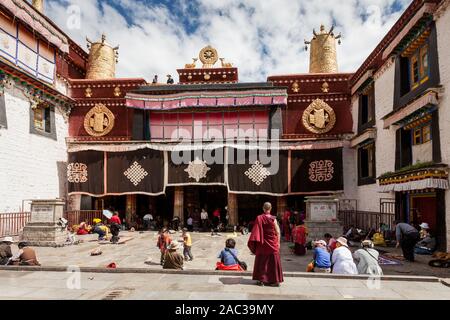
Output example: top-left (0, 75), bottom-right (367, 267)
top-left (67, 151), bottom-right (104, 196)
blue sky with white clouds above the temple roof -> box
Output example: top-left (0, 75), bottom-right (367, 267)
top-left (45, 0), bottom-right (412, 82)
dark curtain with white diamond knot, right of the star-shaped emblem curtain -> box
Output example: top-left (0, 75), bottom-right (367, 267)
top-left (228, 148), bottom-right (288, 195)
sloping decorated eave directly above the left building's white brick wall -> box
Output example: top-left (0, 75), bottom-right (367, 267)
top-left (0, 58), bottom-right (75, 107)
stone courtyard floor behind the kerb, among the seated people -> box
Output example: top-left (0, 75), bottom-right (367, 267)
top-left (5, 231), bottom-right (449, 278)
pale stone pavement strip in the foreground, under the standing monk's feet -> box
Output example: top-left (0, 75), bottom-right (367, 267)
top-left (0, 271), bottom-right (450, 304)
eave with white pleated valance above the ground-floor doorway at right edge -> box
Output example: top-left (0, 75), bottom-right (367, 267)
top-left (378, 164), bottom-right (449, 192)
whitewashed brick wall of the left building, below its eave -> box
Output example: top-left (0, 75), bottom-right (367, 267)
top-left (0, 87), bottom-right (68, 213)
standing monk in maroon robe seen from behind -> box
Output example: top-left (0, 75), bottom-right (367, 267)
top-left (247, 202), bottom-right (283, 286)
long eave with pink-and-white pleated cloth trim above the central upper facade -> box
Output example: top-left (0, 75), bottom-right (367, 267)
top-left (126, 83), bottom-right (287, 110)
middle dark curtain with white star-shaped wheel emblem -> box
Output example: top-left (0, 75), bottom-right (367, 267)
top-left (168, 148), bottom-right (225, 185)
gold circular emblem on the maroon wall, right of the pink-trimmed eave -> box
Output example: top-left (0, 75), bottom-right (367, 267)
top-left (302, 99), bottom-right (336, 133)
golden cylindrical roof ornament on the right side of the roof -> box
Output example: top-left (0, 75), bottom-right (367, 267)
top-left (305, 25), bottom-right (342, 73)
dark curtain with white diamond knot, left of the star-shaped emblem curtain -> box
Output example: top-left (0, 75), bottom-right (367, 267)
top-left (107, 149), bottom-right (164, 194)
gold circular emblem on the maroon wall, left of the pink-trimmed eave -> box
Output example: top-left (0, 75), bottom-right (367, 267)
top-left (84, 104), bottom-right (115, 137)
